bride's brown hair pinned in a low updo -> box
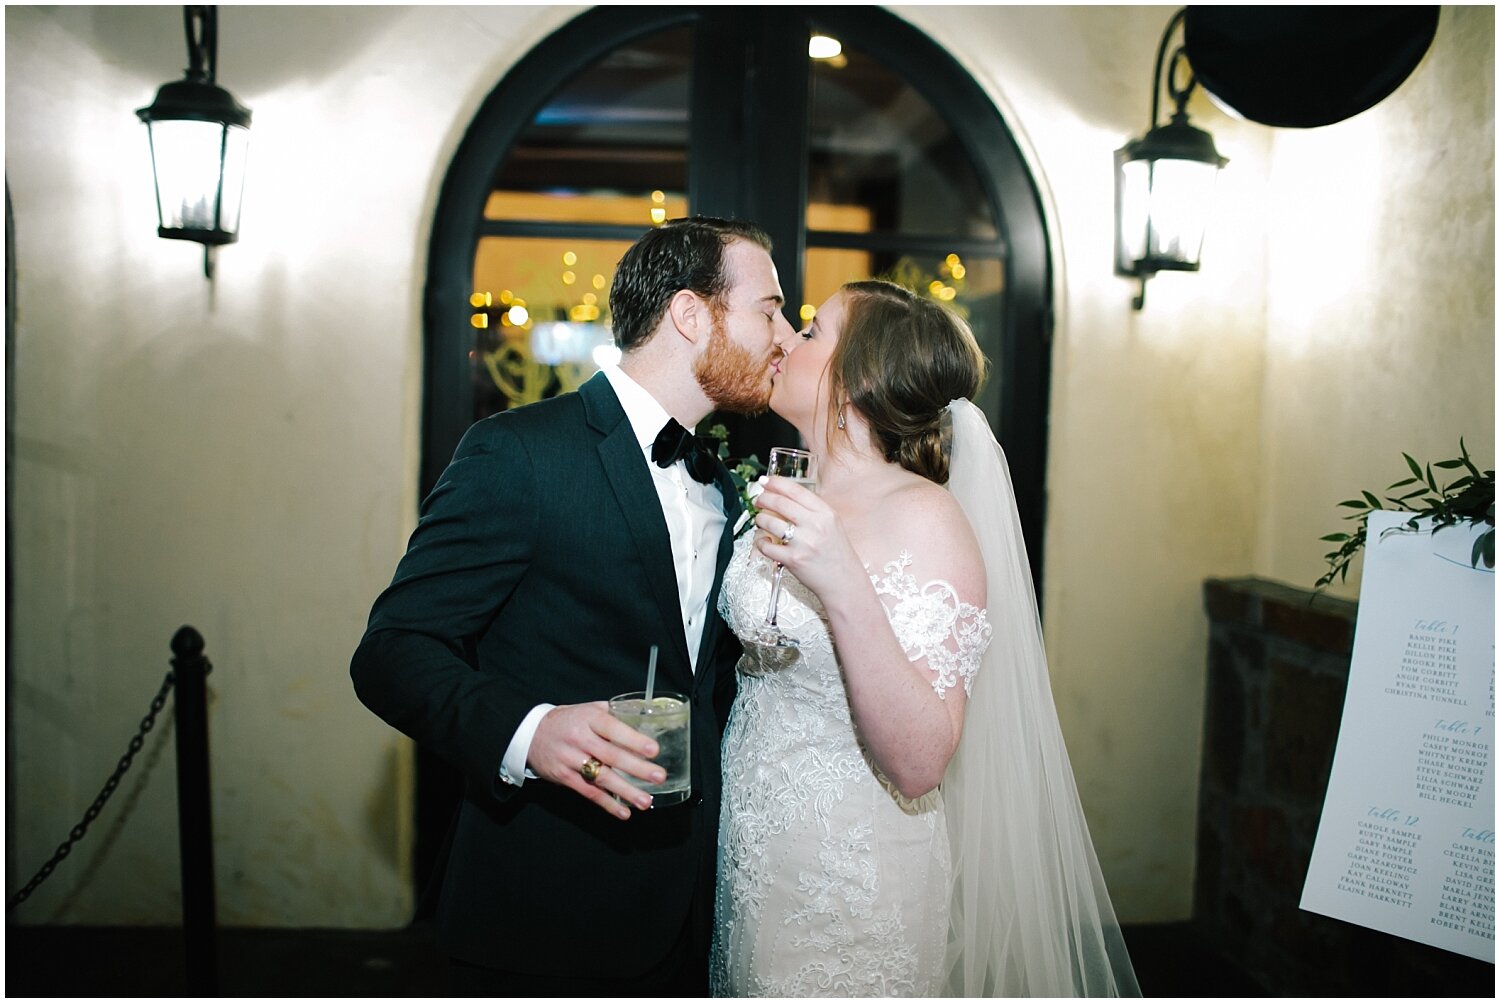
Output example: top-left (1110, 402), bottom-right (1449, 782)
top-left (828, 279), bottom-right (986, 484)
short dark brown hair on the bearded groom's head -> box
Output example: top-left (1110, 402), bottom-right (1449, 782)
top-left (609, 216), bottom-right (771, 352)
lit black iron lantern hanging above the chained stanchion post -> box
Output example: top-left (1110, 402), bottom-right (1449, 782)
top-left (135, 6), bottom-right (251, 277)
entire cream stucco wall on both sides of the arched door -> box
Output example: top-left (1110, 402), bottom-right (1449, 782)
top-left (5, 6), bottom-right (1494, 927)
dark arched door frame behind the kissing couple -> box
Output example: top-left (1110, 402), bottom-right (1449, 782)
top-left (416, 6), bottom-right (1053, 888)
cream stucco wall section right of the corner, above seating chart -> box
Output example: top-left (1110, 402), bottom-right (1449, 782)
top-left (1256, 6), bottom-right (1496, 594)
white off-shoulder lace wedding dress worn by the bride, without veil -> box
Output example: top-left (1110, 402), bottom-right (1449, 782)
top-left (710, 532), bottom-right (990, 997)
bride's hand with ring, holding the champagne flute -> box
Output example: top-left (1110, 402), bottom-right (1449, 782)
top-left (755, 477), bottom-right (864, 604)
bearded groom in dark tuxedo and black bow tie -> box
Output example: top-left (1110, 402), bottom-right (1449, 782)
top-left (350, 217), bottom-right (791, 996)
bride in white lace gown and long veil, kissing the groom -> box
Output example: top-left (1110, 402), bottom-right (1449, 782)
top-left (711, 282), bottom-right (1139, 997)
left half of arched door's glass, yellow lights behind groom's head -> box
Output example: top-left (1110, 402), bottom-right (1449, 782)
top-left (468, 27), bottom-right (693, 420)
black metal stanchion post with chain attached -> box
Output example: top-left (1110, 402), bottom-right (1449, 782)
top-left (173, 627), bottom-right (219, 996)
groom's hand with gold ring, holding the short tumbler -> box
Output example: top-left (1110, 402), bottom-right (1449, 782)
top-left (527, 700), bottom-right (666, 819)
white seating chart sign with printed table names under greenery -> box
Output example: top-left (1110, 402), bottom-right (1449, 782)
top-left (1302, 511), bottom-right (1496, 964)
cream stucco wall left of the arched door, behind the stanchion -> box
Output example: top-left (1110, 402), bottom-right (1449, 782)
top-left (6, 6), bottom-right (572, 927)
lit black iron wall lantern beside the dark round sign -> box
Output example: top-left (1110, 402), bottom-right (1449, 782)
top-left (1115, 7), bottom-right (1229, 310)
